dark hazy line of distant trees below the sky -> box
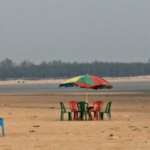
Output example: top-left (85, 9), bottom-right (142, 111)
top-left (0, 58), bottom-right (150, 80)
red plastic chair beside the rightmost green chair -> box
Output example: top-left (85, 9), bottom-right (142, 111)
top-left (93, 101), bottom-right (103, 120)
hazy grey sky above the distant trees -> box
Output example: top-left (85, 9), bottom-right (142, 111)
top-left (0, 0), bottom-right (150, 62)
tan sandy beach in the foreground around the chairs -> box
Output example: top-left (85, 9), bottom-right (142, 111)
top-left (0, 93), bottom-right (150, 150)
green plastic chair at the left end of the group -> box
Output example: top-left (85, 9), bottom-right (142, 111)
top-left (60, 102), bottom-right (72, 121)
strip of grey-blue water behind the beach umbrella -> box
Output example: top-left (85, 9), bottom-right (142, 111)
top-left (0, 82), bottom-right (150, 93)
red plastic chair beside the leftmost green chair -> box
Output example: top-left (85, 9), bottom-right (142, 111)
top-left (69, 100), bottom-right (79, 120)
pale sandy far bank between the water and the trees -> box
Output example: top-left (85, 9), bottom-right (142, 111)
top-left (0, 75), bottom-right (150, 86)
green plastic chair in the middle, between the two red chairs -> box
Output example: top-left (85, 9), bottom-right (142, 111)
top-left (78, 101), bottom-right (88, 120)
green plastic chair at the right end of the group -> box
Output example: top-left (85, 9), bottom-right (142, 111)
top-left (99, 101), bottom-right (112, 120)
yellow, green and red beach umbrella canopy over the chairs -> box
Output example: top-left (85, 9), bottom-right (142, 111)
top-left (59, 75), bottom-right (112, 89)
